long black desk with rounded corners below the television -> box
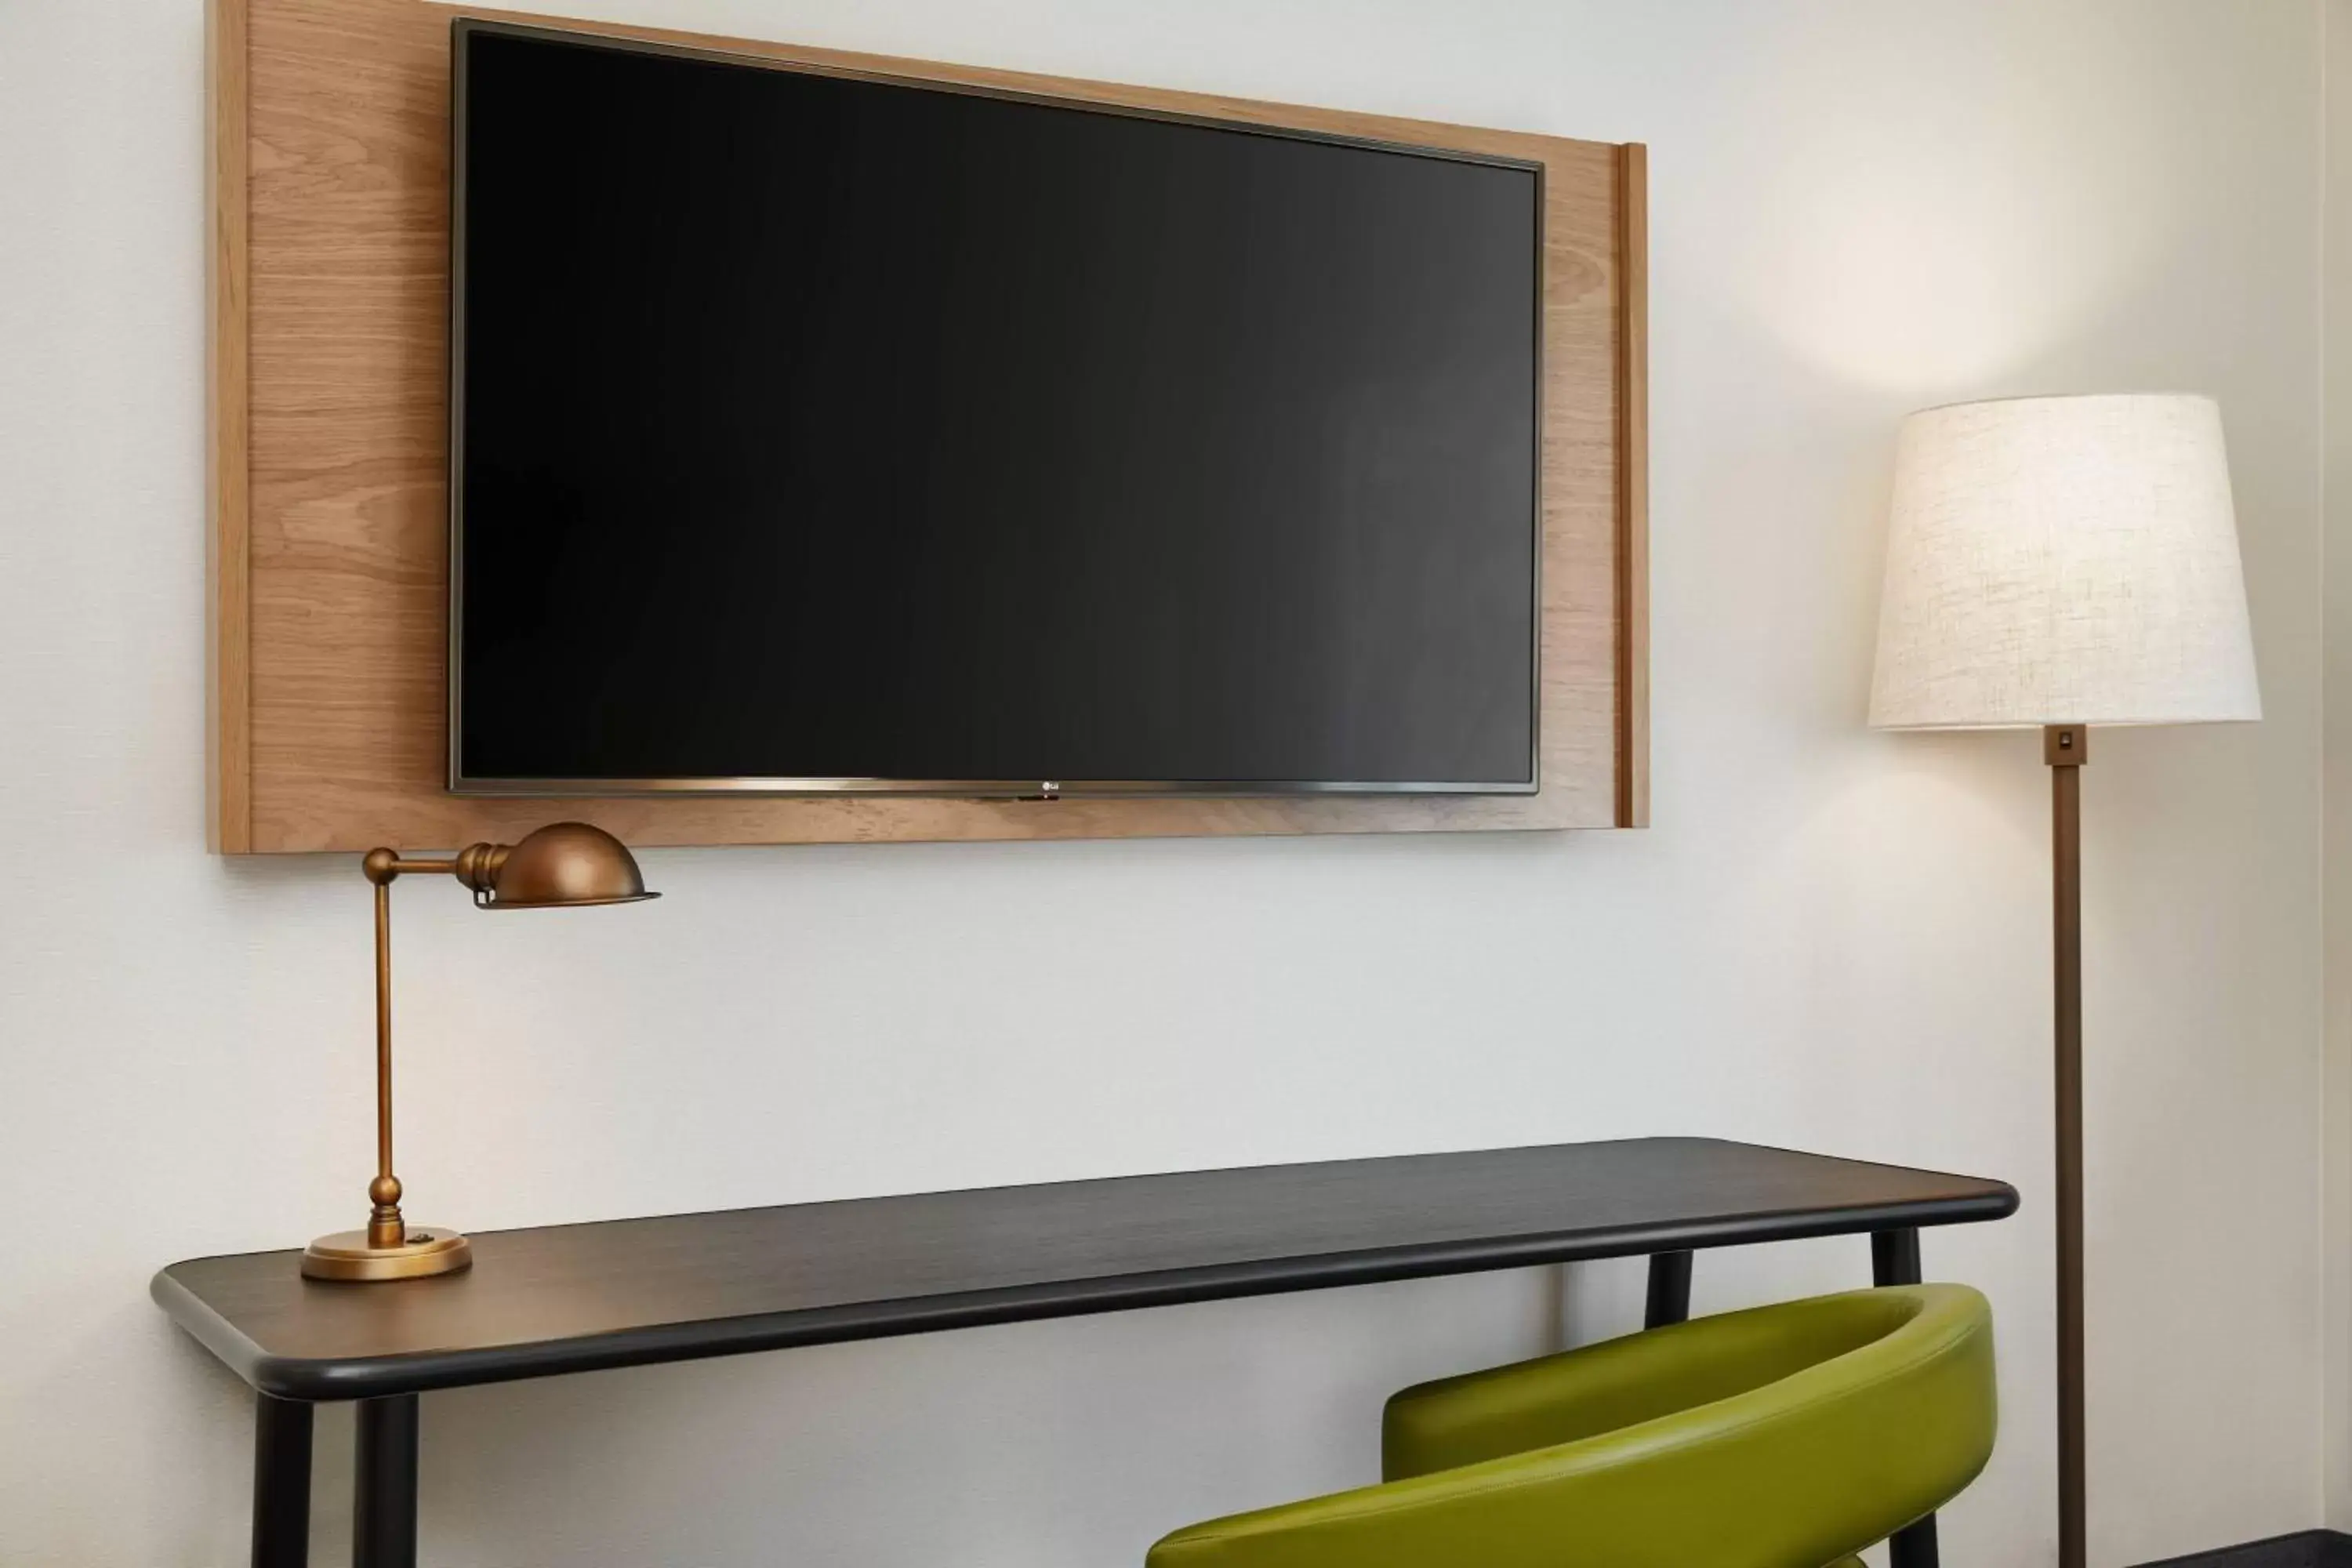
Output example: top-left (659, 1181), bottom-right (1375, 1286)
top-left (153, 1138), bottom-right (2018, 1568)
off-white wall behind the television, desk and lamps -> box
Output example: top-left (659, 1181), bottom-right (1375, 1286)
top-left (0, 0), bottom-right (2340, 1568)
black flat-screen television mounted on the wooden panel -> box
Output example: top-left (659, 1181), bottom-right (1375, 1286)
top-left (449, 21), bottom-right (1543, 794)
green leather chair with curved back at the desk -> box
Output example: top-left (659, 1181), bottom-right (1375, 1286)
top-left (1150, 1286), bottom-right (1994, 1568)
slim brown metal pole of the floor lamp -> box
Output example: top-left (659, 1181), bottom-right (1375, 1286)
top-left (2042, 724), bottom-right (2091, 1568)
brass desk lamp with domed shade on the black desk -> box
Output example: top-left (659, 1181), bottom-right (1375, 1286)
top-left (301, 822), bottom-right (661, 1281)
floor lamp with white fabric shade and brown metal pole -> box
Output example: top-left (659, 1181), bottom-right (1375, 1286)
top-left (1870, 395), bottom-right (2263, 1568)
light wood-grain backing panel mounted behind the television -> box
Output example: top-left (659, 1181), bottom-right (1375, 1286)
top-left (214, 0), bottom-right (1646, 851)
